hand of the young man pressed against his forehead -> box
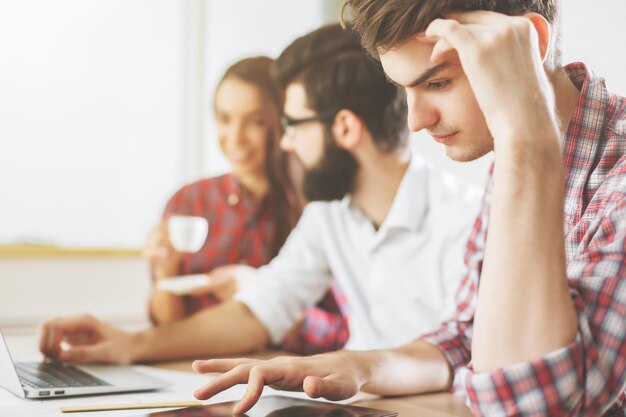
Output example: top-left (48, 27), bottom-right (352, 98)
top-left (416, 11), bottom-right (556, 149)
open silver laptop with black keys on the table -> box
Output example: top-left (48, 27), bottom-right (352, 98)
top-left (0, 330), bottom-right (169, 399)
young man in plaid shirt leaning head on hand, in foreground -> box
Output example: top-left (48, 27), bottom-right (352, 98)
top-left (188, 0), bottom-right (626, 416)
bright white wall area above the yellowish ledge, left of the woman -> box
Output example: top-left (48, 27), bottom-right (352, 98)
top-left (0, 0), bottom-right (184, 247)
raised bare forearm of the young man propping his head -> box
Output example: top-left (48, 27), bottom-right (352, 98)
top-left (472, 137), bottom-right (577, 372)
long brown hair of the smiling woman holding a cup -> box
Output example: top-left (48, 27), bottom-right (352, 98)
top-left (218, 56), bottom-right (301, 256)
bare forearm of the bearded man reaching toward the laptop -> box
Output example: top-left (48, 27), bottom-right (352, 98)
top-left (132, 301), bottom-right (268, 362)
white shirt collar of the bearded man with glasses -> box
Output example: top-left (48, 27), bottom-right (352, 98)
top-left (340, 155), bottom-right (428, 231)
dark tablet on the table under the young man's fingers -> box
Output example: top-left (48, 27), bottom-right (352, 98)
top-left (144, 395), bottom-right (398, 417)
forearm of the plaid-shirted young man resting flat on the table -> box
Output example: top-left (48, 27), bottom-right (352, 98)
top-left (355, 341), bottom-right (452, 395)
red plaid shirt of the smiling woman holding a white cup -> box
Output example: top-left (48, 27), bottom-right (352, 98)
top-left (151, 174), bottom-right (348, 354)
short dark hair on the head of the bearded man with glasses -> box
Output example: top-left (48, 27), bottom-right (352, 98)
top-left (274, 24), bottom-right (408, 151)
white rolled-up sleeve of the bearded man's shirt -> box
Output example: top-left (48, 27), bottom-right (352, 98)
top-left (235, 203), bottom-right (332, 344)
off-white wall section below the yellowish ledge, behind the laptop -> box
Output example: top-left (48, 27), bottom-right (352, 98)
top-left (0, 256), bottom-right (150, 329)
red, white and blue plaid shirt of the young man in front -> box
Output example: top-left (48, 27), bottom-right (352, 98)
top-left (423, 63), bottom-right (626, 416)
